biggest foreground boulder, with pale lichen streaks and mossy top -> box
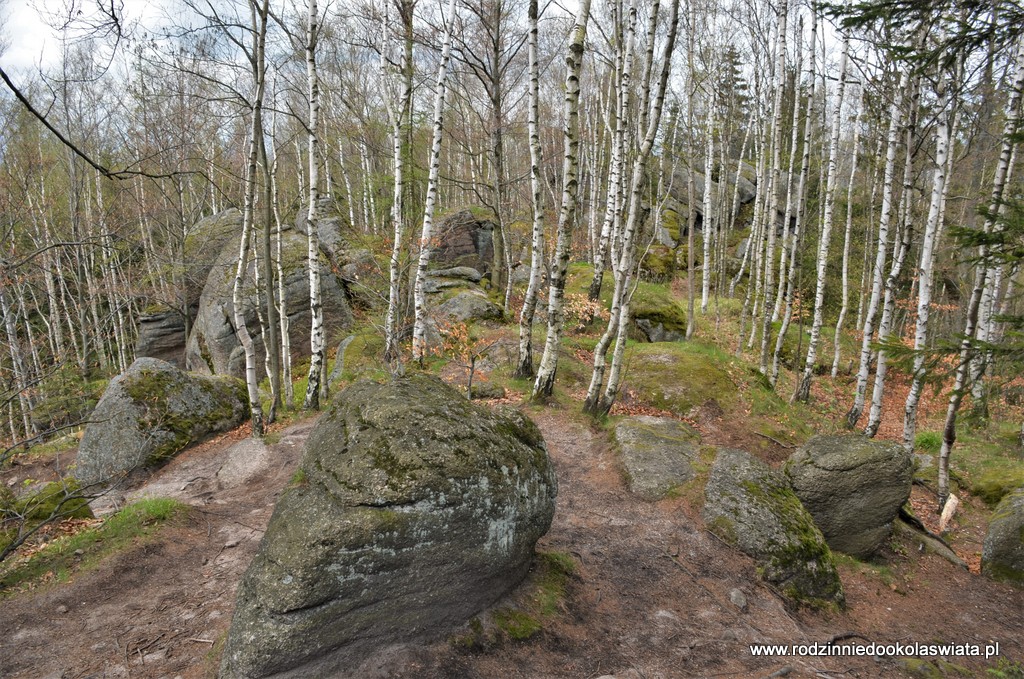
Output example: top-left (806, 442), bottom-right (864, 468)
top-left (221, 375), bottom-right (557, 678)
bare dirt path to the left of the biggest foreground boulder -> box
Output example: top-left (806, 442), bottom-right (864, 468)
top-left (0, 422), bottom-right (312, 679)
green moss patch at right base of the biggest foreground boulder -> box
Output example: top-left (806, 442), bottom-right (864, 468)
top-left (450, 552), bottom-right (578, 650)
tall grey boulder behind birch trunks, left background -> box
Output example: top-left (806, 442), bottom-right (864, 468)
top-left (185, 228), bottom-right (352, 377)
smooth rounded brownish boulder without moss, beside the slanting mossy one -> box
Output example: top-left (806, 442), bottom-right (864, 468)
top-left (785, 434), bottom-right (913, 558)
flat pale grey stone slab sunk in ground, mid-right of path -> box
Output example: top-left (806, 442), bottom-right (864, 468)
top-left (613, 416), bottom-right (700, 501)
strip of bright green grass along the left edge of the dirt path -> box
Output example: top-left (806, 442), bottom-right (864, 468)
top-left (0, 498), bottom-right (188, 597)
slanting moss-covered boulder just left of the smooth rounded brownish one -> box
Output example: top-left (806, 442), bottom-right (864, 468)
top-left (703, 449), bottom-right (844, 606)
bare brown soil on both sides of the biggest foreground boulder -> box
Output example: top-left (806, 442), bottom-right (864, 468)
top-left (0, 408), bottom-right (1024, 679)
